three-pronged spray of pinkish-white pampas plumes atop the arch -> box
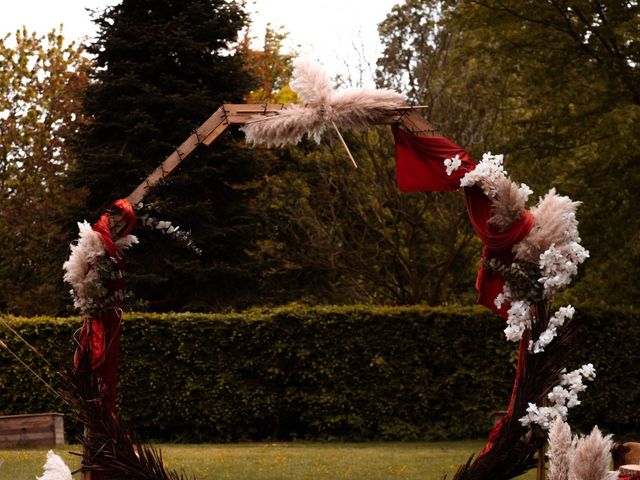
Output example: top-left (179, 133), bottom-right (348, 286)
top-left (242, 59), bottom-right (405, 146)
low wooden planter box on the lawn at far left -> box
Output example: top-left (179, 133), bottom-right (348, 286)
top-left (0, 413), bottom-right (64, 448)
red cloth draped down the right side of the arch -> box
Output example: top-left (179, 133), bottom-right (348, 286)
top-left (393, 127), bottom-right (534, 455)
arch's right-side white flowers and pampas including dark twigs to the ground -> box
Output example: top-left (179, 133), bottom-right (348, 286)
top-left (444, 153), bottom-right (600, 480)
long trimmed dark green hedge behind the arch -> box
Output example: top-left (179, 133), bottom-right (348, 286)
top-left (0, 307), bottom-right (640, 441)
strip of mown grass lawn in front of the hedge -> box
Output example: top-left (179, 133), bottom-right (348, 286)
top-left (0, 441), bottom-right (535, 480)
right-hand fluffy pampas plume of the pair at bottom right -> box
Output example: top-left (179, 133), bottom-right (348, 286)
top-left (569, 427), bottom-right (613, 480)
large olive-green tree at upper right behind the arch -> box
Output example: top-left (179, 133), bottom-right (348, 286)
top-left (379, 0), bottom-right (640, 304)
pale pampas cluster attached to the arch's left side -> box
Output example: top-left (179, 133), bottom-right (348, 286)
top-left (62, 221), bottom-right (106, 313)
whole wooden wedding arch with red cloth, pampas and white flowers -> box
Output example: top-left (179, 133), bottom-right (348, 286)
top-left (57, 62), bottom-right (595, 480)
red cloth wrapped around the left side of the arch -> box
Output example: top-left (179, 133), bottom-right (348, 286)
top-left (75, 199), bottom-right (136, 417)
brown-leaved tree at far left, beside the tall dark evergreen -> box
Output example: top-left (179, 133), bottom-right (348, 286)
top-left (0, 29), bottom-right (89, 315)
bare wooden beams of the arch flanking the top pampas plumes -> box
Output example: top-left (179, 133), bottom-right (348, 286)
top-left (127, 103), bottom-right (438, 206)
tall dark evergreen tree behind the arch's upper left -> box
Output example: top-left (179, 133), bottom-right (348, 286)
top-left (67, 0), bottom-right (260, 310)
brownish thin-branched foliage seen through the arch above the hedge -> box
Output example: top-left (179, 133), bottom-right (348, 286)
top-left (255, 128), bottom-right (477, 305)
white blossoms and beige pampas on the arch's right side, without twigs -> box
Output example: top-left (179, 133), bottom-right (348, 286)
top-left (444, 153), bottom-right (595, 429)
